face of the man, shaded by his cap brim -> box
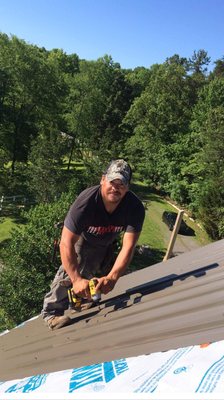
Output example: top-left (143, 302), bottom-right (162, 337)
top-left (100, 176), bottom-right (128, 204)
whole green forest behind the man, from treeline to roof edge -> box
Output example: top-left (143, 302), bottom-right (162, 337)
top-left (0, 33), bottom-right (224, 328)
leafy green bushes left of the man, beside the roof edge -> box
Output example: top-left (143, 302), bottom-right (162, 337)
top-left (0, 180), bottom-right (84, 324)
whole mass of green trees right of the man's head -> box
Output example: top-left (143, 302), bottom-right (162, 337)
top-left (124, 60), bottom-right (224, 239)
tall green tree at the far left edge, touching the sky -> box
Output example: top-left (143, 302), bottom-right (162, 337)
top-left (0, 34), bottom-right (65, 173)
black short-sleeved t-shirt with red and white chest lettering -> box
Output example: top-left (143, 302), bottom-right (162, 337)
top-left (64, 185), bottom-right (145, 246)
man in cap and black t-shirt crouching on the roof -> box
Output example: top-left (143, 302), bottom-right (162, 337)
top-left (42, 159), bottom-right (145, 329)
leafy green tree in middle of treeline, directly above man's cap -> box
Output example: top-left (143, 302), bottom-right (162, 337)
top-left (67, 56), bottom-right (132, 164)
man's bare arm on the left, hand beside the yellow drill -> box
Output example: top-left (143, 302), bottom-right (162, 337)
top-left (60, 226), bottom-right (90, 298)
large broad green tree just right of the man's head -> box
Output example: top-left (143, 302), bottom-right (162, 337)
top-left (124, 63), bottom-right (191, 198)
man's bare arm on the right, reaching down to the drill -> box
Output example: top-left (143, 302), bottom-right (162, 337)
top-left (96, 232), bottom-right (140, 294)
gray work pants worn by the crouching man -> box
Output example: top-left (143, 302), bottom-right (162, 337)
top-left (42, 238), bottom-right (115, 320)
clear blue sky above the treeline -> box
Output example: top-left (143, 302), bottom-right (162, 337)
top-left (0, 0), bottom-right (224, 69)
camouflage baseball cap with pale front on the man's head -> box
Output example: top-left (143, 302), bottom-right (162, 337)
top-left (105, 159), bottom-right (132, 185)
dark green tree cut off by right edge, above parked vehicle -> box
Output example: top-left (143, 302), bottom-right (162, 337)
top-left (189, 78), bottom-right (224, 239)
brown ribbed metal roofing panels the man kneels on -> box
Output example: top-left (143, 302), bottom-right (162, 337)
top-left (0, 240), bottom-right (224, 381)
